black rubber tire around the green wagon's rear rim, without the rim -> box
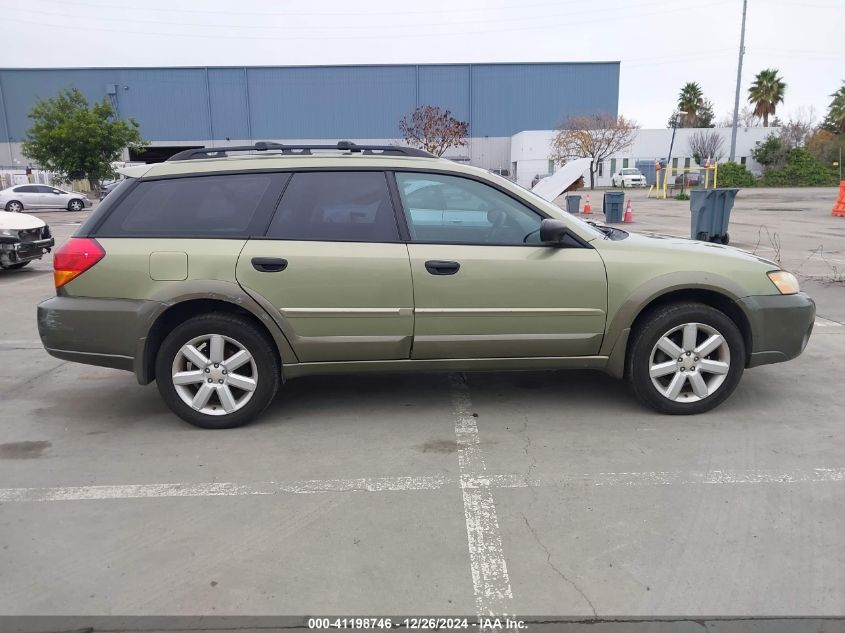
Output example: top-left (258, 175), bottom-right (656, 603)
top-left (156, 312), bottom-right (281, 429)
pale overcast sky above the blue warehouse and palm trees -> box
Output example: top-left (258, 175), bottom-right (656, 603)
top-left (0, 0), bottom-right (845, 127)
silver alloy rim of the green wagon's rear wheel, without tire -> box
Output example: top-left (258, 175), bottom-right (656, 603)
top-left (171, 334), bottom-right (258, 415)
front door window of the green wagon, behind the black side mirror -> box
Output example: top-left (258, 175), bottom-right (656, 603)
top-left (396, 172), bottom-right (542, 245)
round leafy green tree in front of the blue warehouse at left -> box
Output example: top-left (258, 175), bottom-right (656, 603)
top-left (23, 88), bottom-right (146, 189)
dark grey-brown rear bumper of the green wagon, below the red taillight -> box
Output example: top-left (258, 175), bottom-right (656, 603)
top-left (38, 297), bottom-right (164, 378)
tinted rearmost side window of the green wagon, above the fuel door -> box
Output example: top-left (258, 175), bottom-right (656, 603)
top-left (97, 173), bottom-right (278, 237)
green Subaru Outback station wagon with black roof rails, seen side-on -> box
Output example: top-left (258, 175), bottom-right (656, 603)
top-left (38, 142), bottom-right (815, 428)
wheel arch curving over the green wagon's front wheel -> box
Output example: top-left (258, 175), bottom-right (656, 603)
top-left (604, 286), bottom-right (753, 378)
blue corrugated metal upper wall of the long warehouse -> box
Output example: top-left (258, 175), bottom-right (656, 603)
top-left (0, 62), bottom-right (619, 142)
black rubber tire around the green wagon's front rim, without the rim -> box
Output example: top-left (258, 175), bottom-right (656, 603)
top-left (626, 302), bottom-right (745, 415)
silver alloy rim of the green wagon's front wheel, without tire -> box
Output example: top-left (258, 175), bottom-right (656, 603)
top-left (649, 323), bottom-right (731, 402)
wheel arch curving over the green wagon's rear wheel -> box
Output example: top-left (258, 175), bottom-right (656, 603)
top-left (135, 297), bottom-right (297, 385)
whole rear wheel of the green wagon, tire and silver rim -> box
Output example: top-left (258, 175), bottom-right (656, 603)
top-left (156, 312), bottom-right (280, 429)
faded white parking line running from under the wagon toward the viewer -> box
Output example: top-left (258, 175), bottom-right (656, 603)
top-left (449, 374), bottom-right (513, 616)
